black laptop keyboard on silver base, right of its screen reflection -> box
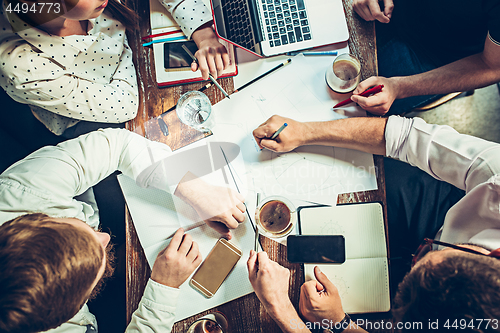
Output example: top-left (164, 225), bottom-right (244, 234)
top-left (261, 0), bottom-right (311, 47)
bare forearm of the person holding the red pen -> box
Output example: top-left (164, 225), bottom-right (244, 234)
top-left (390, 53), bottom-right (500, 99)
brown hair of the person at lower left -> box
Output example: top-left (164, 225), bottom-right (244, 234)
top-left (0, 214), bottom-right (104, 333)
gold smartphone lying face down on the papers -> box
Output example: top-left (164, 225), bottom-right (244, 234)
top-left (189, 238), bottom-right (241, 298)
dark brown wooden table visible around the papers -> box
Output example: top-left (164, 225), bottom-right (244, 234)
top-left (126, 0), bottom-right (387, 333)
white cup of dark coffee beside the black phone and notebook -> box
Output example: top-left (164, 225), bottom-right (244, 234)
top-left (255, 196), bottom-right (297, 238)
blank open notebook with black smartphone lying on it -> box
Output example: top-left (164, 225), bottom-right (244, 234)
top-left (299, 203), bottom-right (390, 313)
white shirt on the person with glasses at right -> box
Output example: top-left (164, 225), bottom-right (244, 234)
top-left (385, 116), bottom-right (500, 250)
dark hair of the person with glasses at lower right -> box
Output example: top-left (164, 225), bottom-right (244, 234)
top-left (392, 252), bottom-right (500, 332)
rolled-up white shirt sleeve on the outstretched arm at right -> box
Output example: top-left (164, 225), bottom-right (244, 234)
top-left (385, 116), bottom-right (500, 192)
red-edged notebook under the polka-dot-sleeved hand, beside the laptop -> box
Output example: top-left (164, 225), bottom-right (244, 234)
top-left (149, 0), bottom-right (238, 87)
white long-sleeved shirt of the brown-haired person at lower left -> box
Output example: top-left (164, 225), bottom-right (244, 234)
top-left (0, 129), bottom-right (186, 333)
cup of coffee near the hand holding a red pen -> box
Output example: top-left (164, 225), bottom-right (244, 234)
top-left (325, 53), bottom-right (361, 94)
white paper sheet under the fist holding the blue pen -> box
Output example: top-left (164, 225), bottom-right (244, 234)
top-left (209, 55), bottom-right (377, 203)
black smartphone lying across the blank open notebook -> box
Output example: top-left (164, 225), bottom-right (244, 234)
top-left (286, 235), bottom-right (345, 264)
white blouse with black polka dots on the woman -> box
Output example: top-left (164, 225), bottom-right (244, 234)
top-left (0, 0), bottom-right (212, 135)
